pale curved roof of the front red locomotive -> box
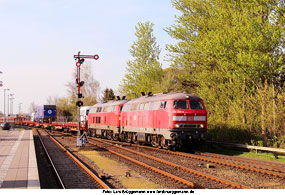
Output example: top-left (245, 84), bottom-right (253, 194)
top-left (124, 92), bottom-right (201, 103)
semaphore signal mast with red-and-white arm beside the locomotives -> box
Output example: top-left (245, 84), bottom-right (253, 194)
top-left (74, 51), bottom-right (99, 146)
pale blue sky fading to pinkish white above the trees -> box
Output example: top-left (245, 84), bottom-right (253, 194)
top-left (0, 0), bottom-right (178, 113)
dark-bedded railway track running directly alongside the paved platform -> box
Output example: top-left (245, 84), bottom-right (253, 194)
top-left (34, 130), bottom-right (110, 189)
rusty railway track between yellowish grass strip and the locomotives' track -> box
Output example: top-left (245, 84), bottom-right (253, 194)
top-left (47, 129), bottom-right (248, 189)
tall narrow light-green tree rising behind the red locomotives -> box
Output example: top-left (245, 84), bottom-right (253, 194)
top-left (120, 22), bottom-right (162, 98)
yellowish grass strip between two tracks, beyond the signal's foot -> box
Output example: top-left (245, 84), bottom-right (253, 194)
top-left (79, 151), bottom-right (161, 189)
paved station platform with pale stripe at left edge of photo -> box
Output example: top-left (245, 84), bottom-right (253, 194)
top-left (0, 130), bottom-right (40, 189)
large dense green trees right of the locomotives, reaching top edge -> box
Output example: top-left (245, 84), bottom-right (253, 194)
top-left (166, 0), bottom-right (285, 146)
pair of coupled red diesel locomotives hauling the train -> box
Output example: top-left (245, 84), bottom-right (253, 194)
top-left (88, 93), bottom-right (207, 148)
